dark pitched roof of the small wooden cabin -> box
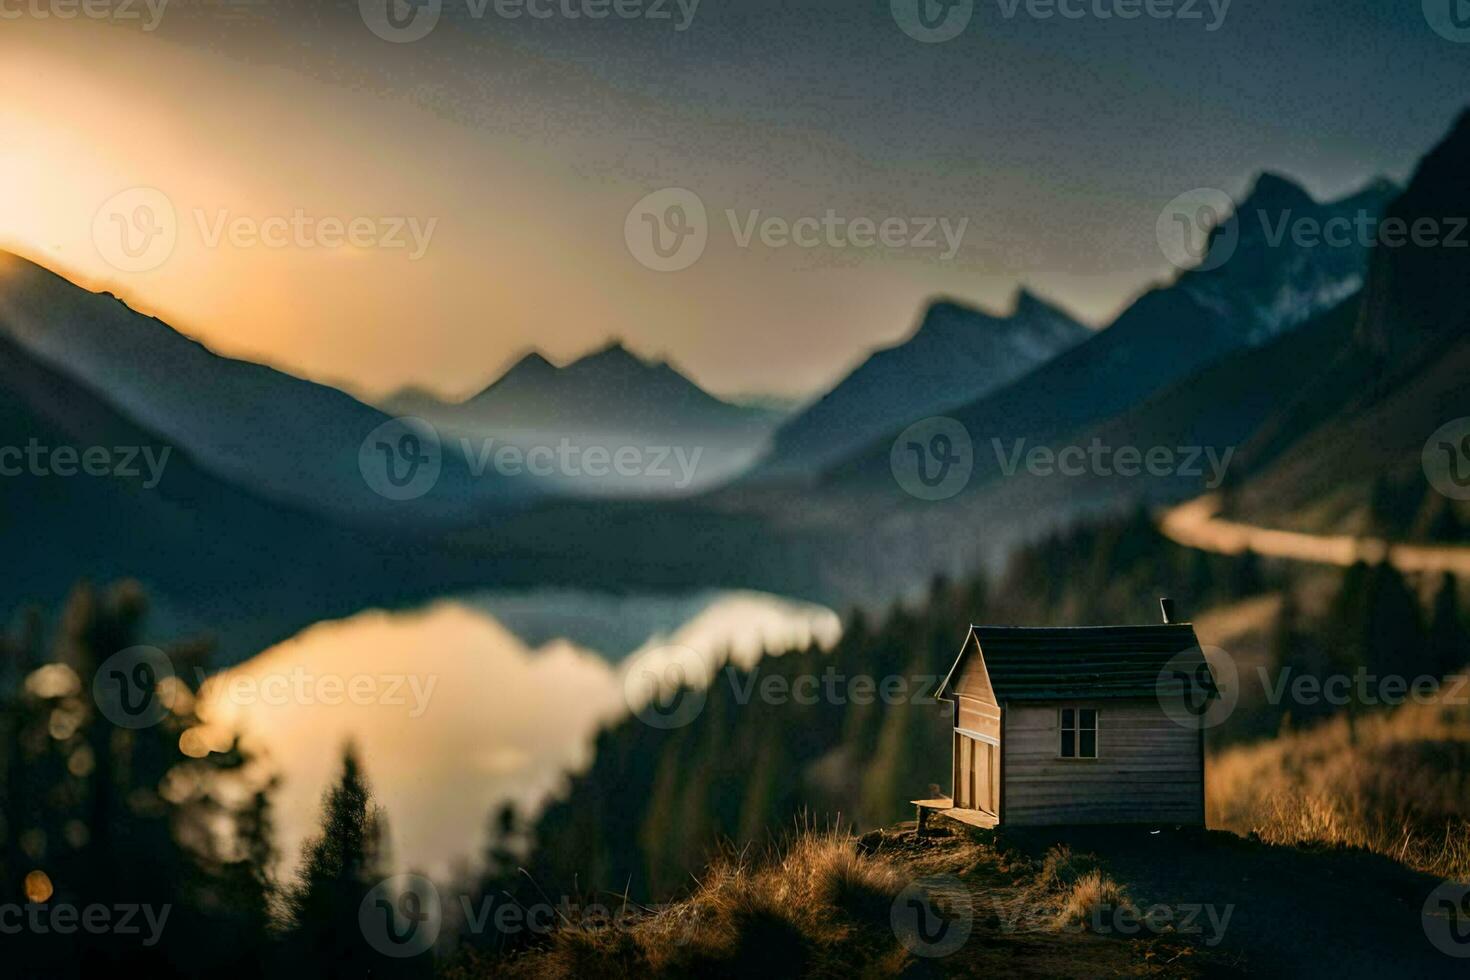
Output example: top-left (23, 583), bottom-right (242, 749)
top-left (938, 623), bottom-right (1219, 704)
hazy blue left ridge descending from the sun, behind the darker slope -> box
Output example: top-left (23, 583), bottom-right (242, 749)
top-left (0, 253), bottom-right (535, 526)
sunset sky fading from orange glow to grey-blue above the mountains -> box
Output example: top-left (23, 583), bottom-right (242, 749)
top-left (0, 0), bottom-right (1470, 398)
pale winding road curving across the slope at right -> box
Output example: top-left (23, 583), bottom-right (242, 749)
top-left (1160, 497), bottom-right (1470, 576)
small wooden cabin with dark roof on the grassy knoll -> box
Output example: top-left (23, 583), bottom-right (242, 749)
top-left (938, 599), bottom-right (1219, 826)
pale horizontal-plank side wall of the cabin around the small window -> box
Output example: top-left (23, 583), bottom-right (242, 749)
top-left (1001, 701), bottom-right (1204, 826)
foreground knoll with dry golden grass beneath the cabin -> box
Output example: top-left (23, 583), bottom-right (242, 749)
top-left (482, 821), bottom-right (1463, 979)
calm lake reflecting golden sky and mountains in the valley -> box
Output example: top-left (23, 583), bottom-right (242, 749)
top-left (200, 589), bottom-right (841, 876)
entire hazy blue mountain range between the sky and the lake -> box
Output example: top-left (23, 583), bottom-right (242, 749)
top-left (0, 107), bottom-right (1470, 644)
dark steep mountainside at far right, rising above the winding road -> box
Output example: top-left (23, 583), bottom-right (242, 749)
top-left (1230, 112), bottom-right (1470, 535)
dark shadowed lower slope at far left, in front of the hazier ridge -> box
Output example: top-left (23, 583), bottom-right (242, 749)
top-left (0, 335), bottom-right (388, 660)
